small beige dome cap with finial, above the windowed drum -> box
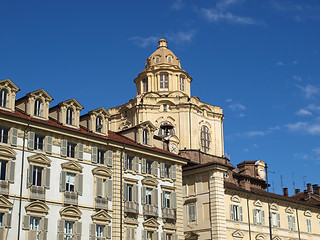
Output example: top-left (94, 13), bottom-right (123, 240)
top-left (146, 38), bottom-right (181, 70)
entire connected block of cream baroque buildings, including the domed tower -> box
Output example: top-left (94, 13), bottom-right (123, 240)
top-left (0, 39), bottom-right (320, 240)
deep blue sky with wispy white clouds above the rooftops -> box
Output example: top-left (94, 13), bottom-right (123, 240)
top-left (0, 0), bottom-right (320, 193)
